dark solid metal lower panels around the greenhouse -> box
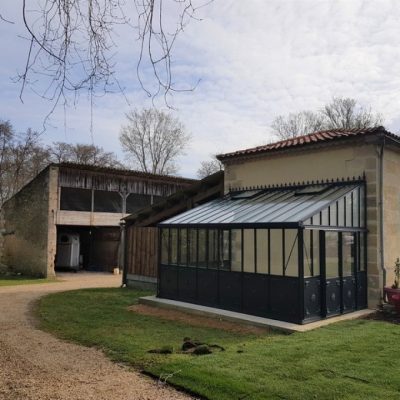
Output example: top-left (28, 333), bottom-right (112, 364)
top-left (158, 265), bottom-right (366, 324)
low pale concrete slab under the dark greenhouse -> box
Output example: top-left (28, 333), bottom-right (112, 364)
top-left (139, 296), bottom-right (374, 333)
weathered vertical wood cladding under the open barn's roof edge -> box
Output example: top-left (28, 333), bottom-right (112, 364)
top-left (59, 169), bottom-right (187, 197)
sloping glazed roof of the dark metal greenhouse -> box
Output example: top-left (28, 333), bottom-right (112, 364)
top-left (160, 182), bottom-right (360, 227)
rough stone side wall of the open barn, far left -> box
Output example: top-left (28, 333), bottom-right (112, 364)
top-left (0, 169), bottom-right (49, 277)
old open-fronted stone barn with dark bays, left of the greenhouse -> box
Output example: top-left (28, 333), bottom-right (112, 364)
top-left (0, 163), bottom-right (195, 277)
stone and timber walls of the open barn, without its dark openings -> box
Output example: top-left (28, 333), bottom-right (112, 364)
top-left (0, 164), bottom-right (192, 277)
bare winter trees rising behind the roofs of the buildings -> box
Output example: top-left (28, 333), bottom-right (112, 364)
top-left (0, 98), bottom-right (383, 206)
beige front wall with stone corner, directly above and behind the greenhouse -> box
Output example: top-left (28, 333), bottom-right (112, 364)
top-left (225, 143), bottom-right (382, 307)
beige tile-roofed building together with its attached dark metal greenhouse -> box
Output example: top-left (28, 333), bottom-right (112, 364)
top-left (158, 127), bottom-right (400, 323)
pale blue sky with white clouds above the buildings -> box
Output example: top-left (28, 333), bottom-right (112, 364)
top-left (0, 0), bottom-right (400, 177)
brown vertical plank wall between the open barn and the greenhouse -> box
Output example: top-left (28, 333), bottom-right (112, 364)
top-left (125, 226), bottom-right (158, 278)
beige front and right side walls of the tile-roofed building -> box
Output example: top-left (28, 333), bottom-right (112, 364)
top-left (225, 141), bottom-right (392, 307)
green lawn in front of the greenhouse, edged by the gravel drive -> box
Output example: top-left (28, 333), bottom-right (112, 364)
top-left (38, 289), bottom-right (400, 400)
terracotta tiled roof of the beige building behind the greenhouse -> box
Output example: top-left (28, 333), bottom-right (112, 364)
top-left (217, 126), bottom-right (399, 161)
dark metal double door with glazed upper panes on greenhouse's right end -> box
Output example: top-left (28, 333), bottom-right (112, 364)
top-left (321, 231), bottom-right (356, 317)
